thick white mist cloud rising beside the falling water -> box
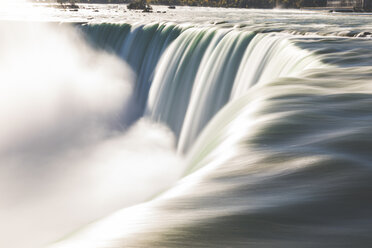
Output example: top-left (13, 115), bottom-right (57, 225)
top-left (0, 23), bottom-right (182, 248)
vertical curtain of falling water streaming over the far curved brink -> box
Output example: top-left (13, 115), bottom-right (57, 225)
top-left (84, 23), bottom-right (322, 153)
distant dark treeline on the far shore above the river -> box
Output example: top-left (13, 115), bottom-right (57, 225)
top-left (38, 0), bottom-right (327, 8)
